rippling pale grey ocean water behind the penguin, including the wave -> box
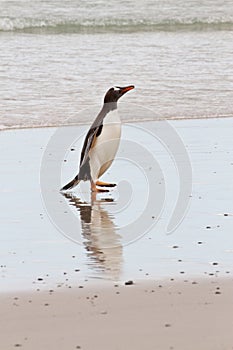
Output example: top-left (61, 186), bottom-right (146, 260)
top-left (0, 0), bottom-right (233, 128)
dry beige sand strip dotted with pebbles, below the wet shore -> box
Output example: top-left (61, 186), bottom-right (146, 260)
top-left (0, 278), bottom-right (233, 350)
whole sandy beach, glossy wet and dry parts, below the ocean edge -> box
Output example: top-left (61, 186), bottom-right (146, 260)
top-left (0, 118), bottom-right (233, 350)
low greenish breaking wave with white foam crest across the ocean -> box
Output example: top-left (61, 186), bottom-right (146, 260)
top-left (0, 17), bottom-right (233, 34)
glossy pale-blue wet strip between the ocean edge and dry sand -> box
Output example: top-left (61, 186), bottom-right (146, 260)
top-left (0, 118), bottom-right (233, 291)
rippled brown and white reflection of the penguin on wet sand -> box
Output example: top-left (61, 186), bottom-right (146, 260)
top-left (63, 193), bottom-right (122, 279)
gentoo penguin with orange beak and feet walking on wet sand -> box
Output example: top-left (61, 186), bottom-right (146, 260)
top-left (61, 85), bottom-right (134, 192)
